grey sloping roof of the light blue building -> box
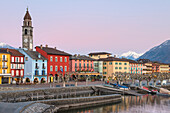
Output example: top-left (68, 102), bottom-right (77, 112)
top-left (24, 50), bottom-right (47, 60)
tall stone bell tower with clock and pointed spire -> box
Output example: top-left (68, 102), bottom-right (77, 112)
top-left (22, 8), bottom-right (33, 50)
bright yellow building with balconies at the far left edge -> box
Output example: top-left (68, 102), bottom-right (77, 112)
top-left (0, 49), bottom-right (11, 84)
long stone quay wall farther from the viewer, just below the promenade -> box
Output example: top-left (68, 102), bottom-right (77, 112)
top-left (0, 86), bottom-right (95, 103)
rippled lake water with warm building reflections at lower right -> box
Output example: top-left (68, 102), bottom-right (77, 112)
top-left (58, 95), bottom-right (170, 113)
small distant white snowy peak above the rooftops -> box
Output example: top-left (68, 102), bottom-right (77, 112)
top-left (120, 51), bottom-right (143, 60)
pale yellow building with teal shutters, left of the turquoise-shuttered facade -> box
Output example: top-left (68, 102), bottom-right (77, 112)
top-left (101, 57), bottom-right (129, 78)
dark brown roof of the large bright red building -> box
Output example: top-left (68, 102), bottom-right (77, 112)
top-left (37, 46), bottom-right (72, 56)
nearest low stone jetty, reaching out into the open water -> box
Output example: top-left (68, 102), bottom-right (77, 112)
top-left (20, 94), bottom-right (121, 113)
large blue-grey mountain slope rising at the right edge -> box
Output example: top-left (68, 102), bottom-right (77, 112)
top-left (139, 40), bottom-right (170, 63)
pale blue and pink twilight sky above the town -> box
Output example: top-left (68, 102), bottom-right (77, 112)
top-left (0, 0), bottom-right (170, 54)
